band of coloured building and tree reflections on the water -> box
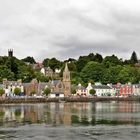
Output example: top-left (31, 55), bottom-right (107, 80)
top-left (0, 102), bottom-right (140, 127)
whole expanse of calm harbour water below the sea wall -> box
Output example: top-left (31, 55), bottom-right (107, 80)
top-left (0, 101), bottom-right (140, 140)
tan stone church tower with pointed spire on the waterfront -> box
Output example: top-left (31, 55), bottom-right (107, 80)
top-left (63, 63), bottom-right (71, 97)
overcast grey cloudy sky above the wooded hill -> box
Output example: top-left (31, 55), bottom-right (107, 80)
top-left (0, 0), bottom-right (140, 61)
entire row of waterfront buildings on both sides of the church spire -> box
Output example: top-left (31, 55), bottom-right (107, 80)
top-left (0, 79), bottom-right (140, 97)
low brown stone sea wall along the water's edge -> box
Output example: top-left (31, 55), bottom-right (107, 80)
top-left (0, 96), bottom-right (140, 104)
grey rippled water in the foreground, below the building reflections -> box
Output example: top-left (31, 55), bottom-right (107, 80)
top-left (0, 125), bottom-right (140, 140)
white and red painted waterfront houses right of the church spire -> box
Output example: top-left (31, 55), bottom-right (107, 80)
top-left (76, 83), bottom-right (140, 96)
